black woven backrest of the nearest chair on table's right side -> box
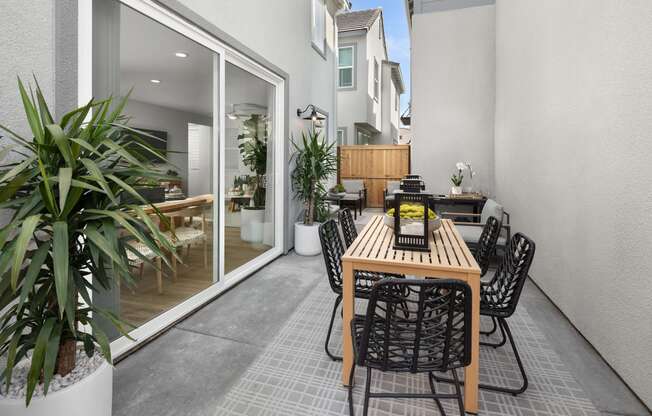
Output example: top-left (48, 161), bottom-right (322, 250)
top-left (485, 233), bottom-right (536, 317)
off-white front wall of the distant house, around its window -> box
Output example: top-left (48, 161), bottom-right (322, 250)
top-left (336, 31), bottom-right (368, 144)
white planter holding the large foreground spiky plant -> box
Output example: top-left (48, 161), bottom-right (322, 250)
top-left (0, 362), bottom-right (113, 416)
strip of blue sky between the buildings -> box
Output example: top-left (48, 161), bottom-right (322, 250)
top-left (351, 0), bottom-right (410, 113)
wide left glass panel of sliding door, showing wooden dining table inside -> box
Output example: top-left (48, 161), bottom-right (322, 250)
top-left (93, 1), bottom-right (218, 339)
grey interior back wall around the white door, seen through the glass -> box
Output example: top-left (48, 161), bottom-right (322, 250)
top-left (125, 100), bottom-right (213, 191)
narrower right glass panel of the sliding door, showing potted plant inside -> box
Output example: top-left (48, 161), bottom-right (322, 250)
top-left (224, 62), bottom-right (275, 273)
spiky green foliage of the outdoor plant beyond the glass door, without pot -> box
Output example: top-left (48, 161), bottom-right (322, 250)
top-left (291, 129), bottom-right (337, 225)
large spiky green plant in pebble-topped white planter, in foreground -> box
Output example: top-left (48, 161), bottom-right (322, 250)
top-left (0, 80), bottom-right (173, 416)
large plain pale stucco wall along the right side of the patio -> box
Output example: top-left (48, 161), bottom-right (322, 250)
top-left (494, 0), bottom-right (652, 406)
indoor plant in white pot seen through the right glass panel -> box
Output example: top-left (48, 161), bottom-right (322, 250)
top-left (238, 114), bottom-right (268, 243)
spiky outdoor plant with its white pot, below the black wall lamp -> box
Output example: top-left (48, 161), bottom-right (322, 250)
top-left (292, 130), bottom-right (337, 256)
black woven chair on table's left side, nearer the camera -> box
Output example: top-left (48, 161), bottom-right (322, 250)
top-left (319, 220), bottom-right (404, 361)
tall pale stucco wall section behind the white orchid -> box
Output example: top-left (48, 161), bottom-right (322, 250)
top-left (411, 5), bottom-right (495, 194)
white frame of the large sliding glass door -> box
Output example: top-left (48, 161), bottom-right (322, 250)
top-left (77, 0), bottom-right (286, 357)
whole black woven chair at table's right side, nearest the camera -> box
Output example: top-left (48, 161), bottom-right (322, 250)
top-left (437, 233), bottom-right (535, 396)
